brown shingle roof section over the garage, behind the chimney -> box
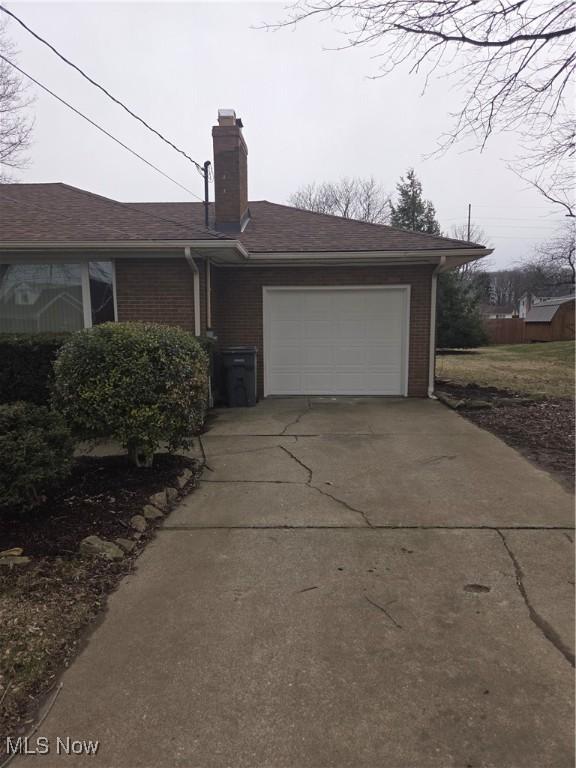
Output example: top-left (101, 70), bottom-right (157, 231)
top-left (136, 200), bottom-right (483, 253)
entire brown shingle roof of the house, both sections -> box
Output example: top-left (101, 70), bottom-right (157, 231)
top-left (0, 183), bottom-right (483, 253)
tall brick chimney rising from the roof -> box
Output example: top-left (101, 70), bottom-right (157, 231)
top-left (212, 109), bottom-right (250, 232)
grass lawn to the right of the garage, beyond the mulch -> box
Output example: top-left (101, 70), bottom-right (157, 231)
top-left (436, 341), bottom-right (574, 397)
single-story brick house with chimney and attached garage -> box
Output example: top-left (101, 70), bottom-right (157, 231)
top-left (0, 110), bottom-right (491, 397)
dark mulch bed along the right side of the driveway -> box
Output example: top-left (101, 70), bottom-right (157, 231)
top-left (436, 381), bottom-right (575, 490)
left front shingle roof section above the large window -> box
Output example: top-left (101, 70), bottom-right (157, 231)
top-left (0, 183), bottom-right (227, 243)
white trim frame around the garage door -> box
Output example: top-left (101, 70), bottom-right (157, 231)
top-left (262, 283), bottom-right (412, 397)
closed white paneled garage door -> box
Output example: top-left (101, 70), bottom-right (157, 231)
top-left (263, 286), bottom-right (410, 395)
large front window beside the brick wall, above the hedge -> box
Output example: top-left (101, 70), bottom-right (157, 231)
top-left (0, 261), bottom-right (115, 333)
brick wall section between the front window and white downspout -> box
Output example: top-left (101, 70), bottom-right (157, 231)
top-left (116, 257), bottom-right (198, 331)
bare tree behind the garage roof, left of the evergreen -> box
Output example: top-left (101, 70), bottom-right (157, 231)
top-left (289, 177), bottom-right (390, 224)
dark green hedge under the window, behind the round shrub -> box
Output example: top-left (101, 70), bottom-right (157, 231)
top-left (0, 333), bottom-right (69, 405)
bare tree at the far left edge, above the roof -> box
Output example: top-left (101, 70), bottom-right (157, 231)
top-left (0, 22), bottom-right (32, 183)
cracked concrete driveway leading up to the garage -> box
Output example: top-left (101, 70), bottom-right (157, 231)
top-left (18, 398), bottom-right (574, 768)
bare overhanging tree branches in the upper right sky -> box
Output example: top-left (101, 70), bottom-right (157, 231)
top-left (268, 0), bottom-right (576, 195)
